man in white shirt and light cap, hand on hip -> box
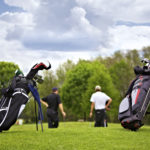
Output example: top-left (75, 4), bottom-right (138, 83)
top-left (90, 85), bottom-right (112, 127)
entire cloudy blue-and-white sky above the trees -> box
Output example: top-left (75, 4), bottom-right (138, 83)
top-left (0, 0), bottom-right (150, 73)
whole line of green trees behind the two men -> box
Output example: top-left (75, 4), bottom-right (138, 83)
top-left (0, 47), bottom-right (150, 122)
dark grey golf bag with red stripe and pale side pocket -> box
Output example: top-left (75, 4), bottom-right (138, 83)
top-left (118, 58), bottom-right (150, 131)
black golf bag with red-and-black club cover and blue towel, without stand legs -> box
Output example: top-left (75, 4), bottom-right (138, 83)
top-left (0, 63), bottom-right (50, 131)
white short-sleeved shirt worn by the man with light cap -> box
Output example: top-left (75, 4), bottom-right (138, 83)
top-left (90, 91), bottom-right (111, 110)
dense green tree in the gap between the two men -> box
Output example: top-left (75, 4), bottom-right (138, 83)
top-left (61, 61), bottom-right (92, 118)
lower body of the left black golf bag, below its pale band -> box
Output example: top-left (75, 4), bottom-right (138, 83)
top-left (0, 88), bottom-right (28, 131)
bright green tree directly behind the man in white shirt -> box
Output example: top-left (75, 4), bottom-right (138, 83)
top-left (83, 61), bottom-right (120, 121)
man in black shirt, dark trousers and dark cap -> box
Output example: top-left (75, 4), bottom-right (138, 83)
top-left (41, 88), bottom-right (66, 128)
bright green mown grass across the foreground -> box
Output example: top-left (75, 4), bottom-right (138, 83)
top-left (0, 122), bottom-right (150, 150)
